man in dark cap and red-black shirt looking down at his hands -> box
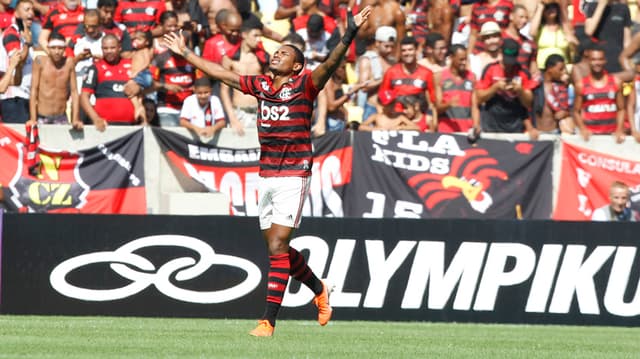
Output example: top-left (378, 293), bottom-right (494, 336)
top-left (476, 38), bottom-right (538, 139)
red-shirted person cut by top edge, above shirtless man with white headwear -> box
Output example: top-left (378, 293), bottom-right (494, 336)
top-left (38, 0), bottom-right (84, 51)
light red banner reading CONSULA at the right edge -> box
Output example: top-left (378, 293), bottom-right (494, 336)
top-left (553, 142), bottom-right (640, 221)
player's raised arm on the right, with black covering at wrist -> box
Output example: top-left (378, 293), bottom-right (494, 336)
top-left (311, 6), bottom-right (371, 89)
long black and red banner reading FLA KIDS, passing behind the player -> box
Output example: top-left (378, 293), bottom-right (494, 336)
top-left (154, 129), bottom-right (553, 219)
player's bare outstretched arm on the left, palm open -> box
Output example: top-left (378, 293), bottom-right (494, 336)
top-left (164, 30), bottom-right (240, 90)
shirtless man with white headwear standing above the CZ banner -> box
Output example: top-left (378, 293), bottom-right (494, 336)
top-left (28, 34), bottom-right (83, 130)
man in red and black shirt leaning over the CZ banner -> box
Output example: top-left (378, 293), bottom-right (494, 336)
top-left (80, 34), bottom-right (135, 131)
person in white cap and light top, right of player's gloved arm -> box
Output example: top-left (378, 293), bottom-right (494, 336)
top-left (356, 26), bottom-right (398, 121)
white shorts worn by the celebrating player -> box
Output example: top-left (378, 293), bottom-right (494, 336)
top-left (258, 177), bottom-right (311, 230)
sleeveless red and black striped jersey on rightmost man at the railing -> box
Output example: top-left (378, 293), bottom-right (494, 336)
top-left (582, 74), bottom-right (619, 134)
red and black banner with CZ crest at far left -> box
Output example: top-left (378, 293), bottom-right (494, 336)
top-left (0, 125), bottom-right (147, 214)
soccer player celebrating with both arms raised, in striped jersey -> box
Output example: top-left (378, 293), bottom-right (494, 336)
top-left (164, 6), bottom-right (371, 337)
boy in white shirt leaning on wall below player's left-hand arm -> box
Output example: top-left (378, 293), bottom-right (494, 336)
top-left (180, 77), bottom-right (226, 137)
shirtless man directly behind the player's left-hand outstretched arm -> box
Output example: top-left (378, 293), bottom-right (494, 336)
top-left (220, 17), bottom-right (268, 135)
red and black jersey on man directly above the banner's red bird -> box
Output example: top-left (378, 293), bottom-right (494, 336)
top-left (438, 67), bottom-right (476, 132)
